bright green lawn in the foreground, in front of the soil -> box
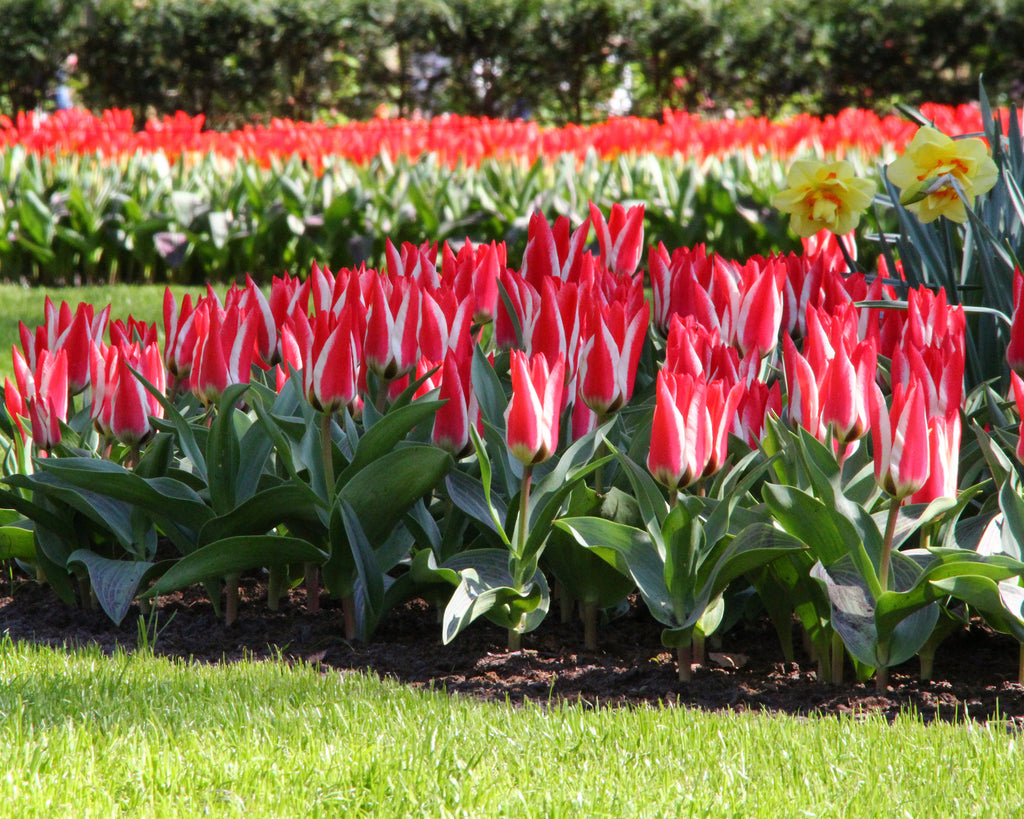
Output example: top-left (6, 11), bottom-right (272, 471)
top-left (0, 640), bottom-right (1024, 818)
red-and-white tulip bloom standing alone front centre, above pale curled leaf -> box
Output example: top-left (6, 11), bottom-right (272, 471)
top-left (505, 350), bottom-right (565, 466)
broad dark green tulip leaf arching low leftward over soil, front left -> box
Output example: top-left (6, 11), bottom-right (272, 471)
top-left (142, 534), bottom-right (327, 598)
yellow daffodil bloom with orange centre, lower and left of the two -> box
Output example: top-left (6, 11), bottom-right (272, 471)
top-left (771, 160), bottom-right (874, 239)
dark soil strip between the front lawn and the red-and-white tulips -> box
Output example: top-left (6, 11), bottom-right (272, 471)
top-left (0, 578), bottom-right (1024, 729)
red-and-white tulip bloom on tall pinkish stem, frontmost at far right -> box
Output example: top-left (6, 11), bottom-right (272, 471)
top-left (870, 380), bottom-right (931, 501)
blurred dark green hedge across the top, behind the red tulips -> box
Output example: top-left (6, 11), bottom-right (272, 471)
top-left (0, 0), bottom-right (1024, 123)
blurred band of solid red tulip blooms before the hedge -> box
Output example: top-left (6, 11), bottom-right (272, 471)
top-left (0, 104), bottom-right (1007, 168)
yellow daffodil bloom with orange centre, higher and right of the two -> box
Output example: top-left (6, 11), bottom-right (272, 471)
top-left (888, 127), bottom-right (999, 222)
